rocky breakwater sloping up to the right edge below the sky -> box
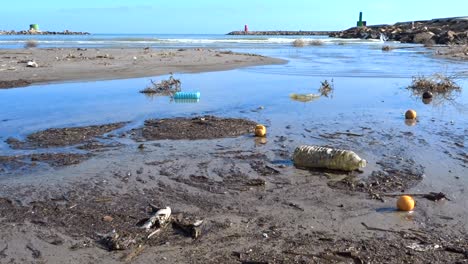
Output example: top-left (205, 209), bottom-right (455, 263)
top-left (329, 17), bottom-right (468, 45)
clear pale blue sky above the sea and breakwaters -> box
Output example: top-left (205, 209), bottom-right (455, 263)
top-left (0, 0), bottom-right (468, 34)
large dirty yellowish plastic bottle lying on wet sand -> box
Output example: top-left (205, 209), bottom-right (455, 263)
top-left (293, 145), bottom-right (367, 171)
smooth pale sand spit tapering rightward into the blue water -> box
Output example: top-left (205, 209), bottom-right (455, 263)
top-left (0, 48), bottom-right (285, 88)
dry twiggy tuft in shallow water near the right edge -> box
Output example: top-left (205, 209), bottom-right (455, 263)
top-left (407, 73), bottom-right (461, 100)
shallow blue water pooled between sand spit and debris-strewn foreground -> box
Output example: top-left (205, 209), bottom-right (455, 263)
top-left (0, 39), bottom-right (468, 197)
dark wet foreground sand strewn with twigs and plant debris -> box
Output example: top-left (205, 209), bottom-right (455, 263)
top-left (0, 117), bottom-right (468, 263)
